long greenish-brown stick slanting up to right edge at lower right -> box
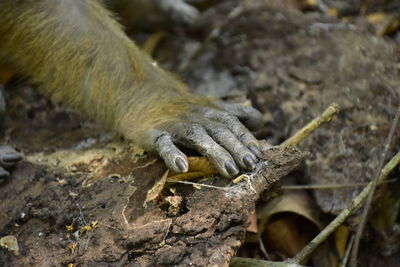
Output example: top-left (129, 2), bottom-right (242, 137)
top-left (288, 152), bottom-right (400, 263)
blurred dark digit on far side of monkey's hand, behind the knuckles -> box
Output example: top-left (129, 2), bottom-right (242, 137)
top-left (217, 102), bottom-right (263, 131)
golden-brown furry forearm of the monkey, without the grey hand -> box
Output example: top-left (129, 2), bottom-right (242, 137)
top-left (0, 0), bottom-right (210, 150)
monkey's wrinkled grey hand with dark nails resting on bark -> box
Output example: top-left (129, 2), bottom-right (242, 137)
top-left (120, 99), bottom-right (262, 177)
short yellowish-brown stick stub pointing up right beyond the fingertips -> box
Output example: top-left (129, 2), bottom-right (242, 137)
top-left (280, 103), bottom-right (339, 147)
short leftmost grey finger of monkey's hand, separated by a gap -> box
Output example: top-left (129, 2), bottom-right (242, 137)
top-left (154, 134), bottom-right (189, 173)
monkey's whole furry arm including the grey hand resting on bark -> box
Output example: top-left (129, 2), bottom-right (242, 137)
top-left (0, 0), bottom-right (261, 177)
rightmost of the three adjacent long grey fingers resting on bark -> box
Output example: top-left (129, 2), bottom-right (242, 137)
top-left (200, 109), bottom-right (262, 158)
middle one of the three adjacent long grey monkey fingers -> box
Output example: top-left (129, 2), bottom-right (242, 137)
top-left (206, 123), bottom-right (257, 170)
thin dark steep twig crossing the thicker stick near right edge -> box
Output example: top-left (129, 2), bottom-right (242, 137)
top-left (350, 103), bottom-right (400, 267)
